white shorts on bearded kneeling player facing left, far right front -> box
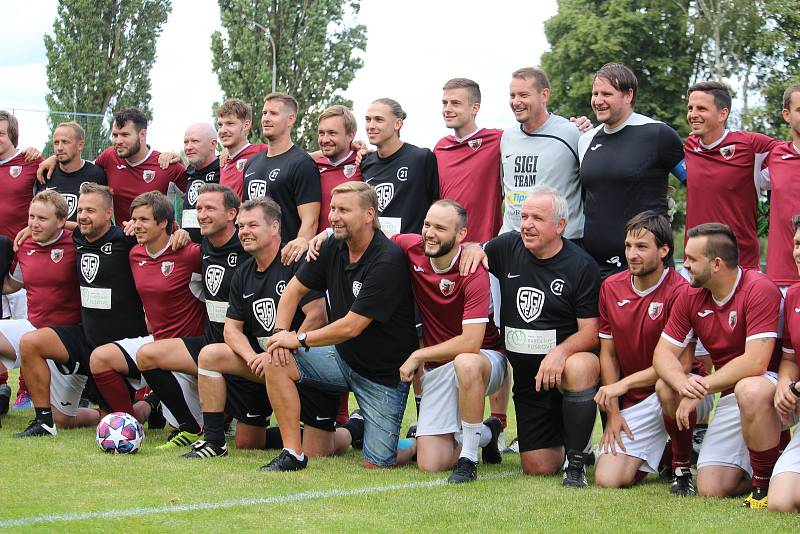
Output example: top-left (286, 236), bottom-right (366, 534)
top-left (697, 371), bottom-right (778, 476)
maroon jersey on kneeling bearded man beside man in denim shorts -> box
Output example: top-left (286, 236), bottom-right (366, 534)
top-left (392, 234), bottom-right (502, 367)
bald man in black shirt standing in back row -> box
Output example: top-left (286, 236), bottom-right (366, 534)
top-left (181, 122), bottom-right (220, 244)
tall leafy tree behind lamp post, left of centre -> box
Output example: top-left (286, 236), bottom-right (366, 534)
top-left (211, 0), bottom-right (367, 149)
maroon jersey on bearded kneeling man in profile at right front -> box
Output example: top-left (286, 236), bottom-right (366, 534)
top-left (661, 269), bottom-right (782, 384)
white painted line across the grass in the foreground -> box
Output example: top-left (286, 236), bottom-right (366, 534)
top-left (0, 470), bottom-right (519, 528)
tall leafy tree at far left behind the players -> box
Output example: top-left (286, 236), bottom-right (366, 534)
top-left (44, 0), bottom-right (172, 157)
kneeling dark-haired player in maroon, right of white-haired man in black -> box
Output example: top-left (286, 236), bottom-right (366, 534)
top-left (594, 211), bottom-right (713, 496)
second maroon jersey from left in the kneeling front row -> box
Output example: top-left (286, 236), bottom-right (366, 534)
top-left (129, 243), bottom-right (205, 339)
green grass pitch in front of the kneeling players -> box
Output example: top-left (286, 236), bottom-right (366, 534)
top-left (0, 373), bottom-right (800, 533)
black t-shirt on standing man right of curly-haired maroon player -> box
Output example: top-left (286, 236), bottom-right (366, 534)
top-left (244, 145), bottom-right (322, 243)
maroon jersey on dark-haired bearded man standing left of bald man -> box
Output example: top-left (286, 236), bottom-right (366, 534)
top-left (94, 147), bottom-right (186, 224)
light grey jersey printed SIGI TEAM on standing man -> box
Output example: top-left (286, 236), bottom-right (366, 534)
top-left (500, 119), bottom-right (583, 239)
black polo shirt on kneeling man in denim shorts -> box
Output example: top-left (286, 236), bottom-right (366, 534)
top-left (296, 231), bottom-right (418, 387)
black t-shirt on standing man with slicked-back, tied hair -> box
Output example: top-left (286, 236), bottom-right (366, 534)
top-left (361, 143), bottom-right (439, 234)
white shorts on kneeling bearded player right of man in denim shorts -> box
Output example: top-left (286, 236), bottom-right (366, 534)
top-left (417, 349), bottom-right (507, 436)
